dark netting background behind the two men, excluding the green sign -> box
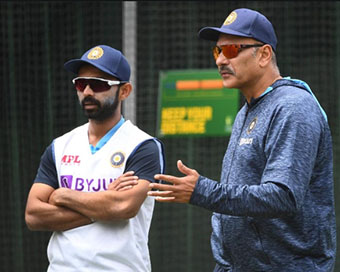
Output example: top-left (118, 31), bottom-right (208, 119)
top-left (0, 1), bottom-right (340, 272)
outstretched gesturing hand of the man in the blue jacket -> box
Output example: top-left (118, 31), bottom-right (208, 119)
top-left (148, 160), bottom-right (200, 203)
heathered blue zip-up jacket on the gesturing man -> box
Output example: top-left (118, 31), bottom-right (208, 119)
top-left (190, 79), bottom-right (336, 272)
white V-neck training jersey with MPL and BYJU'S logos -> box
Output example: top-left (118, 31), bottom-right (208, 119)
top-left (47, 121), bottom-right (162, 272)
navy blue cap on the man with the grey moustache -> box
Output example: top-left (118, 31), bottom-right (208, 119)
top-left (198, 8), bottom-right (277, 51)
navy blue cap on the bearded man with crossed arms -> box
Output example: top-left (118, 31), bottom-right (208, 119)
top-left (64, 45), bottom-right (131, 82)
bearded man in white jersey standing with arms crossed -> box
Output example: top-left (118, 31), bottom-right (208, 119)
top-left (25, 45), bottom-right (164, 272)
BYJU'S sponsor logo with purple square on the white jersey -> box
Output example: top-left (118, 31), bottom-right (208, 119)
top-left (60, 175), bottom-right (116, 192)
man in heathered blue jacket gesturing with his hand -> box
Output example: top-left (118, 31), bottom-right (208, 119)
top-left (149, 8), bottom-right (336, 272)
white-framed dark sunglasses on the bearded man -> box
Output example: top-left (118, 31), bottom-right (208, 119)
top-left (72, 77), bottom-right (125, 93)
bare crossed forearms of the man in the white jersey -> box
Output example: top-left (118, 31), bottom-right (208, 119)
top-left (25, 172), bottom-right (146, 231)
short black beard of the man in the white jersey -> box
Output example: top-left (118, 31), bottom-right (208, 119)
top-left (81, 89), bottom-right (119, 121)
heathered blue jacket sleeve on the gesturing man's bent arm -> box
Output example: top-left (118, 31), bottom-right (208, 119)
top-left (191, 93), bottom-right (325, 217)
